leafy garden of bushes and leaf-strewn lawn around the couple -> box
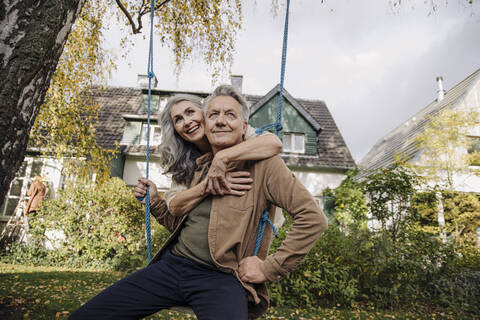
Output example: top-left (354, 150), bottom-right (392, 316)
top-left (0, 165), bottom-right (480, 319)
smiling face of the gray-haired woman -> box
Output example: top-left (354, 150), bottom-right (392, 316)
top-left (170, 101), bottom-right (205, 144)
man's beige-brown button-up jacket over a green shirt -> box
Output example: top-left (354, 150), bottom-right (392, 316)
top-left (151, 153), bottom-right (327, 318)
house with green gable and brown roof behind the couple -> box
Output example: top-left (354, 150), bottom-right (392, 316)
top-left (0, 76), bottom-right (355, 230)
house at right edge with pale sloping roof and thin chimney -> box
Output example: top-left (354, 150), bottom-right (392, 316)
top-left (359, 69), bottom-right (480, 193)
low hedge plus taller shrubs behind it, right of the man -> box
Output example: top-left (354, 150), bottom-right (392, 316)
top-left (269, 165), bottom-right (480, 315)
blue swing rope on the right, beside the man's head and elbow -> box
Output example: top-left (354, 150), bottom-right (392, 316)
top-left (253, 0), bottom-right (290, 256)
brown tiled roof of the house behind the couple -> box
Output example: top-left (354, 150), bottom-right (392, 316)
top-left (93, 86), bottom-right (355, 170)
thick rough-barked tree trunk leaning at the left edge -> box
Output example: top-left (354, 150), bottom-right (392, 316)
top-left (0, 0), bottom-right (85, 205)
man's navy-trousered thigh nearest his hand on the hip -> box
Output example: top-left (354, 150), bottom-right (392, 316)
top-left (180, 263), bottom-right (248, 320)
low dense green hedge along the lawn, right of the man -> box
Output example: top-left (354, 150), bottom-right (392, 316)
top-left (269, 219), bottom-right (480, 314)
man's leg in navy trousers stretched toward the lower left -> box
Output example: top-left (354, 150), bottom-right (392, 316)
top-left (70, 253), bottom-right (184, 320)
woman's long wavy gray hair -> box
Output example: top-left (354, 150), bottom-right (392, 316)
top-left (159, 94), bottom-right (202, 186)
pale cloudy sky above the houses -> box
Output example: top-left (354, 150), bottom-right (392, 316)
top-left (106, 0), bottom-right (480, 163)
